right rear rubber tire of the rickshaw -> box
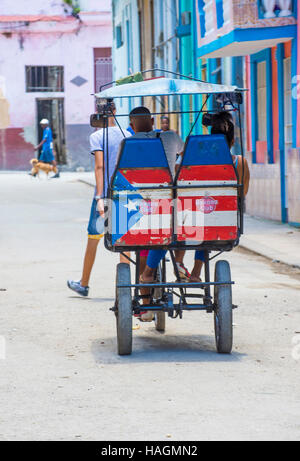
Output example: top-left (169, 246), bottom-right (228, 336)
top-left (214, 261), bottom-right (232, 354)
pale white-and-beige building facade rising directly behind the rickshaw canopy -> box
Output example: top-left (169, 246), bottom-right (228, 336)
top-left (112, 0), bottom-right (179, 129)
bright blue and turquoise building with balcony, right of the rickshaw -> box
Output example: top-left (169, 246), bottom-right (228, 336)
top-left (178, 0), bottom-right (300, 225)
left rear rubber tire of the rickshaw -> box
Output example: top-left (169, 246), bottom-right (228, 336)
top-left (116, 263), bottom-right (132, 355)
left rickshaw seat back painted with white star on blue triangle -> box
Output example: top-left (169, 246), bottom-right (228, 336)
top-left (108, 137), bottom-right (172, 248)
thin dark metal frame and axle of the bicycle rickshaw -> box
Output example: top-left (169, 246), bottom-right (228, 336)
top-left (97, 70), bottom-right (244, 355)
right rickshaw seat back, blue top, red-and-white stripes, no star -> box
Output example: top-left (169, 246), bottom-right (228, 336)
top-left (175, 135), bottom-right (238, 244)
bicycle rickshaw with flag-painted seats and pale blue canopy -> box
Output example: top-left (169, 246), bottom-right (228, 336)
top-left (95, 71), bottom-right (244, 355)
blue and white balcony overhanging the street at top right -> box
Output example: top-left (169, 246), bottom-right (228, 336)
top-left (198, 0), bottom-right (297, 58)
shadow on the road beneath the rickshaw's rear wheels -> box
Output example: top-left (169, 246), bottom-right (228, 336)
top-left (92, 331), bottom-right (246, 364)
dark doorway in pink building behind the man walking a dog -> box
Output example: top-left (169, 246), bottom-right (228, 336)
top-left (36, 98), bottom-right (67, 165)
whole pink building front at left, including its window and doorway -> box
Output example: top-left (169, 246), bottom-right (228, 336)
top-left (0, 0), bottom-right (112, 170)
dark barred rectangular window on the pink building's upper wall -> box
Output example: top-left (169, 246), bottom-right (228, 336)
top-left (26, 66), bottom-right (64, 92)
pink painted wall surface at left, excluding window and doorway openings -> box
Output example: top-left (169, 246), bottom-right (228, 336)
top-left (0, 0), bottom-right (112, 169)
